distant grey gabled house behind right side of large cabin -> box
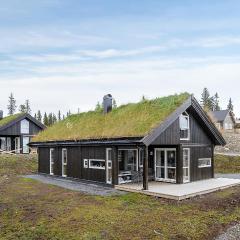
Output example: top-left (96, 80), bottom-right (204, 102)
top-left (210, 110), bottom-right (236, 131)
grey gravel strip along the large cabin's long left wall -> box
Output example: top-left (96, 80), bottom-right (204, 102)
top-left (24, 174), bottom-right (126, 196)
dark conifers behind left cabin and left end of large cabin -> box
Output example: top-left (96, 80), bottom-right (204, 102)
top-left (7, 93), bottom-right (71, 126)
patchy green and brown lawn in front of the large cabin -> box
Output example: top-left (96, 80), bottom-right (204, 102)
top-left (0, 155), bottom-right (240, 240)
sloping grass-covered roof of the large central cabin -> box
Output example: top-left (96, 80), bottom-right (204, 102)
top-left (33, 93), bottom-right (190, 142)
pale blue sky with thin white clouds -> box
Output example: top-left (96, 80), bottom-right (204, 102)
top-left (0, 0), bottom-right (240, 117)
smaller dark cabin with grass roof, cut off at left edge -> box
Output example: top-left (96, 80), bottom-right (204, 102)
top-left (0, 111), bottom-right (45, 154)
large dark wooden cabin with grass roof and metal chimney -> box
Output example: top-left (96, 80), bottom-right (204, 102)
top-left (30, 93), bottom-right (225, 189)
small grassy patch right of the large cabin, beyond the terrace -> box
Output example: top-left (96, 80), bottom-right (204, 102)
top-left (215, 155), bottom-right (240, 173)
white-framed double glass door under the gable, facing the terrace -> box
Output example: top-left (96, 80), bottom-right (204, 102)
top-left (155, 148), bottom-right (176, 182)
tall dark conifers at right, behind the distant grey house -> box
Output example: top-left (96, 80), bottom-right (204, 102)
top-left (201, 87), bottom-right (234, 112)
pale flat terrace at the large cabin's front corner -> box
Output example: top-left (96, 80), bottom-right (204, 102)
top-left (115, 178), bottom-right (240, 200)
